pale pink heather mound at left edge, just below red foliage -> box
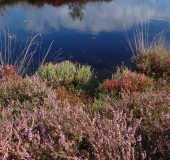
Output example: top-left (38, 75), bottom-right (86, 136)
top-left (0, 76), bottom-right (50, 106)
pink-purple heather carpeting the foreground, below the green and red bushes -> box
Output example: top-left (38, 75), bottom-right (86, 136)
top-left (0, 64), bottom-right (170, 160)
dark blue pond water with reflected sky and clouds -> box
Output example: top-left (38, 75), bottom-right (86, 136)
top-left (0, 0), bottom-right (170, 78)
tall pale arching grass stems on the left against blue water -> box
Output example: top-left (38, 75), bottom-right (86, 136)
top-left (0, 28), bottom-right (53, 76)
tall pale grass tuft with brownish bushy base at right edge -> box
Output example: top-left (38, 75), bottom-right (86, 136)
top-left (125, 19), bottom-right (170, 79)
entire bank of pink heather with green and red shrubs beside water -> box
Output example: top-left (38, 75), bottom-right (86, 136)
top-left (0, 46), bottom-right (170, 160)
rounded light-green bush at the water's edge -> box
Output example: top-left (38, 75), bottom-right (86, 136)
top-left (39, 61), bottom-right (93, 87)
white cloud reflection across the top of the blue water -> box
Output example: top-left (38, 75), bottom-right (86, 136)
top-left (0, 0), bottom-right (170, 34)
